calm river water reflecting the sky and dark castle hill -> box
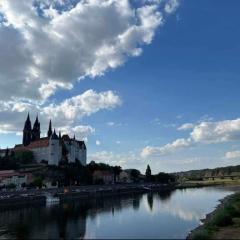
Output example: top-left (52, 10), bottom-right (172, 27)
top-left (0, 188), bottom-right (236, 239)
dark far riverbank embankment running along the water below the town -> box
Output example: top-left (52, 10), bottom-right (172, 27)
top-left (0, 183), bottom-right (237, 209)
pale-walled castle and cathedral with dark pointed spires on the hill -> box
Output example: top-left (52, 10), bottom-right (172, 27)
top-left (12, 114), bottom-right (87, 165)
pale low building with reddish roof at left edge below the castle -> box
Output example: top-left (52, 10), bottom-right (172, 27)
top-left (0, 170), bottom-right (27, 188)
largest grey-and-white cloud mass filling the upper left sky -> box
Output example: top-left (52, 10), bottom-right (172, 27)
top-left (0, 0), bottom-right (178, 101)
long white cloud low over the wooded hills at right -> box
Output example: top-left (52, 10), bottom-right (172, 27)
top-left (141, 119), bottom-right (240, 158)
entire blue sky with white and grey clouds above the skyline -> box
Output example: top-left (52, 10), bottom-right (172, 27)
top-left (0, 0), bottom-right (240, 173)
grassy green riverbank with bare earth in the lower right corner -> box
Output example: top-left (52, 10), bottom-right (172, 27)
top-left (188, 193), bottom-right (240, 240)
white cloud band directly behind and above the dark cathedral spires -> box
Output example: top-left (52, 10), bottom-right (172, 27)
top-left (0, 89), bottom-right (121, 139)
